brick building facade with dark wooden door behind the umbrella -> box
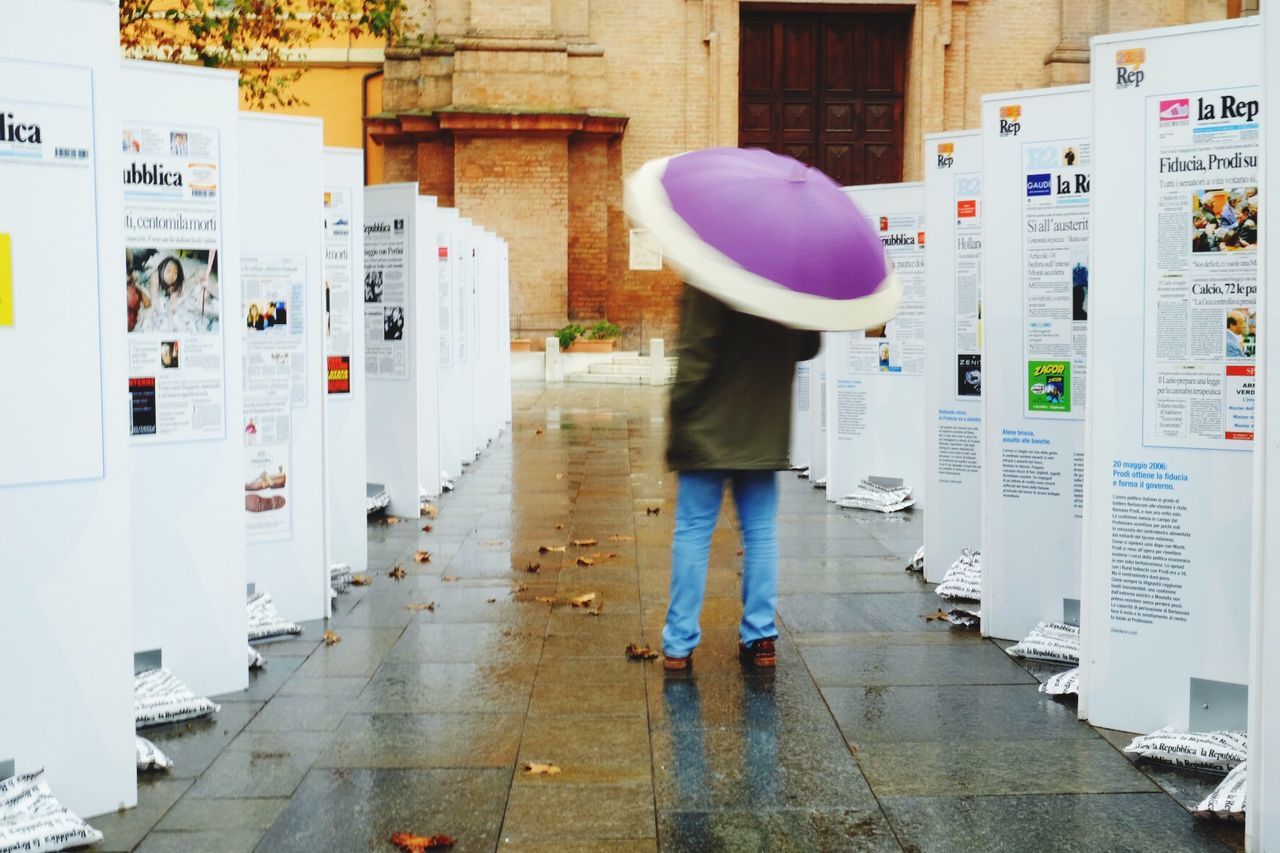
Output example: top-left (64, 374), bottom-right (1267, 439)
top-left (369, 0), bottom-right (1257, 346)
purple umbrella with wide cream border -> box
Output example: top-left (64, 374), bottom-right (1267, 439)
top-left (626, 149), bottom-right (900, 332)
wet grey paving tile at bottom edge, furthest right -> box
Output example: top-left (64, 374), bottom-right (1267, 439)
top-left (881, 794), bottom-right (1231, 853)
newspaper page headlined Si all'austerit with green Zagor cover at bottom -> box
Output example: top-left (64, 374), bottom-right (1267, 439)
top-left (1023, 138), bottom-right (1092, 420)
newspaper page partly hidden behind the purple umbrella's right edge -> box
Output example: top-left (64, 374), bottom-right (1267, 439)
top-left (847, 213), bottom-right (924, 375)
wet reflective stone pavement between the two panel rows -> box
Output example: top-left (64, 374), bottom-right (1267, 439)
top-left (104, 383), bottom-right (1243, 853)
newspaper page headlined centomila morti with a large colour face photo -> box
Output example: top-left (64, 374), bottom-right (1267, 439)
top-left (122, 123), bottom-right (227, 443)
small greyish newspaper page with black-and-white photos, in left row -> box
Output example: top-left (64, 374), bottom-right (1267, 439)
top-left (365, 216), bottom-right (410, 379)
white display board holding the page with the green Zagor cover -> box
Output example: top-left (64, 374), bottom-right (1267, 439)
top-left (980, 86), bottom-right (1092, 639)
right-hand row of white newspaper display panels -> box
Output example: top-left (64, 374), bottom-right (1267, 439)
top-left (792, 19), bottom-right (1280, 849)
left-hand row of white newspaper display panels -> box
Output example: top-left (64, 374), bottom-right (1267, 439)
top-left (0, 23), bottom-right (511, 815)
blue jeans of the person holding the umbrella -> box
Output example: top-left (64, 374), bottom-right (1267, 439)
top-left (662, 471), bottom-right (778, 657)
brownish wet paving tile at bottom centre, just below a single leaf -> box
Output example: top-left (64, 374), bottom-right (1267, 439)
top-left (502, 777), bottom-right (657, 841)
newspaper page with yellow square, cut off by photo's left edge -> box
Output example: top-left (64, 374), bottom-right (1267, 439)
top-left (0, 60), bottom-right (102, 487)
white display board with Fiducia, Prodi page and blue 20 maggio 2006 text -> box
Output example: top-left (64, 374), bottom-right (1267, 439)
top-left (1085, 19), bottom-right (1262, 731)
